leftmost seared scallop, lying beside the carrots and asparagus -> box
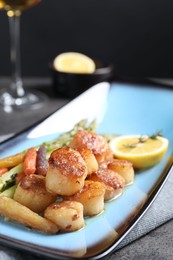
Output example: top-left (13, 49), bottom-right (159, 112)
top-left (14, 174), bottom-right (57, 213)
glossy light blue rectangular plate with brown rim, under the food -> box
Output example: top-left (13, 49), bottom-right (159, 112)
top-left (0, 82), bottom-right (173, 259)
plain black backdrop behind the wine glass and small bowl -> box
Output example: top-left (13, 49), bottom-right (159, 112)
top-left (0, 0), bottom-right (173, 78)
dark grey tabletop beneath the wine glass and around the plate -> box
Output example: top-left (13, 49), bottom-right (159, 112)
top-left (0, 78), bottom-right (173, 260)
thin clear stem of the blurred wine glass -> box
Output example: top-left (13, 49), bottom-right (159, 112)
top-left (7, 11), bottom-right (25, 98)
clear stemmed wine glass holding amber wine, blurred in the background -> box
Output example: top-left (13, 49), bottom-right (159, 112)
top-left (0, 0), bottom-right (45, 112)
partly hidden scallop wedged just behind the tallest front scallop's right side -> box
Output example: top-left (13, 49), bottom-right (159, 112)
top-left (78, 148), bottom-right (98, 175)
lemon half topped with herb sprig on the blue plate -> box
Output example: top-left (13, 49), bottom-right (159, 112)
top-left (109, 135), bottom-right (169, 169)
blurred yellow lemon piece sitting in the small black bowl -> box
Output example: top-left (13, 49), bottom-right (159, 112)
top-left (54, 52), bottom-right (95, 73)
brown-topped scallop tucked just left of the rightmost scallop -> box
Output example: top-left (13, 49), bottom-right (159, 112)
top-left (89, 168), bottom-right (125, 201)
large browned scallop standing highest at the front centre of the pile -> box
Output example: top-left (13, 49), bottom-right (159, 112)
top-left (46, 146), bottom-right (87, 196)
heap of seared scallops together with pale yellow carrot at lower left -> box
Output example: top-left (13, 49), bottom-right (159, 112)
top-left (0, 130), bottom-right (134, 233)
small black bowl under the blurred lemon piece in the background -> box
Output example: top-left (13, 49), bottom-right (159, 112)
top-left (50, 60), bottom-right (113, 98)
